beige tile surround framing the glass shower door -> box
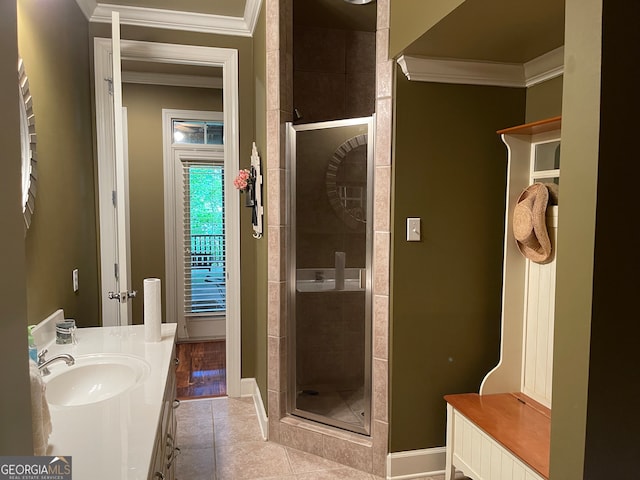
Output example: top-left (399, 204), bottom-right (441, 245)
top-left (266, 0), bottom-right (393, 476)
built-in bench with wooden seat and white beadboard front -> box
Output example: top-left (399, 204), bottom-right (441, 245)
top-left (445, 393), bottom-right (551, 480)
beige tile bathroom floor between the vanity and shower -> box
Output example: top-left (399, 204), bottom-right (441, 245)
top-left (176, 397), bottom-right (444, 480)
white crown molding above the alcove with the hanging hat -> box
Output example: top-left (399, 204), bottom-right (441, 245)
top-left (397, 47), bottom-right (564, 88)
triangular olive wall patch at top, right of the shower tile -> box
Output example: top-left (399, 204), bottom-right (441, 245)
top-left (389, 0), bottom-right (465, 58)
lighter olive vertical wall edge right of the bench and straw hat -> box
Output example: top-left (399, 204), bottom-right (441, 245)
top-left (550, 0), bottom-right (600, 479)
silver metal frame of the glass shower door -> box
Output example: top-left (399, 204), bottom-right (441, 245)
top-left (286, 114), bottom-right (375, 436)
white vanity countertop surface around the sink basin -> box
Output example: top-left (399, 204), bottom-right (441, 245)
top-left (46, 323), bottom-right (176, 480)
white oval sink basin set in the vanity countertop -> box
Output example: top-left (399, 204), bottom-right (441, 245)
top-left (44, 354), bottom-right (150, 407)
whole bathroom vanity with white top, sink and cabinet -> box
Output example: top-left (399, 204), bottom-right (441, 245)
top-left (41, 324), bottom-right (179, 480)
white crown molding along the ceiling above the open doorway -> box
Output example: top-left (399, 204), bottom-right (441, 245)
top-left (90, 0), bottom-right (262, 37)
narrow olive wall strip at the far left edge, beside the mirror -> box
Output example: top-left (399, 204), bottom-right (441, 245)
top-left (0, 0), bottom-right (33, 455)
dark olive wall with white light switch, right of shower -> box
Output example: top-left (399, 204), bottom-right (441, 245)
top-left (389, 69), bottom-right (526, 452)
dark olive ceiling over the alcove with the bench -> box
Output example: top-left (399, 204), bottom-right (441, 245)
top-left (404, 0), bottom-right (565, 63)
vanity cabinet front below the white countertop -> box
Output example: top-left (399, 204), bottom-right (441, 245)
top-left (149, 345), bottom-right (180, 480)
